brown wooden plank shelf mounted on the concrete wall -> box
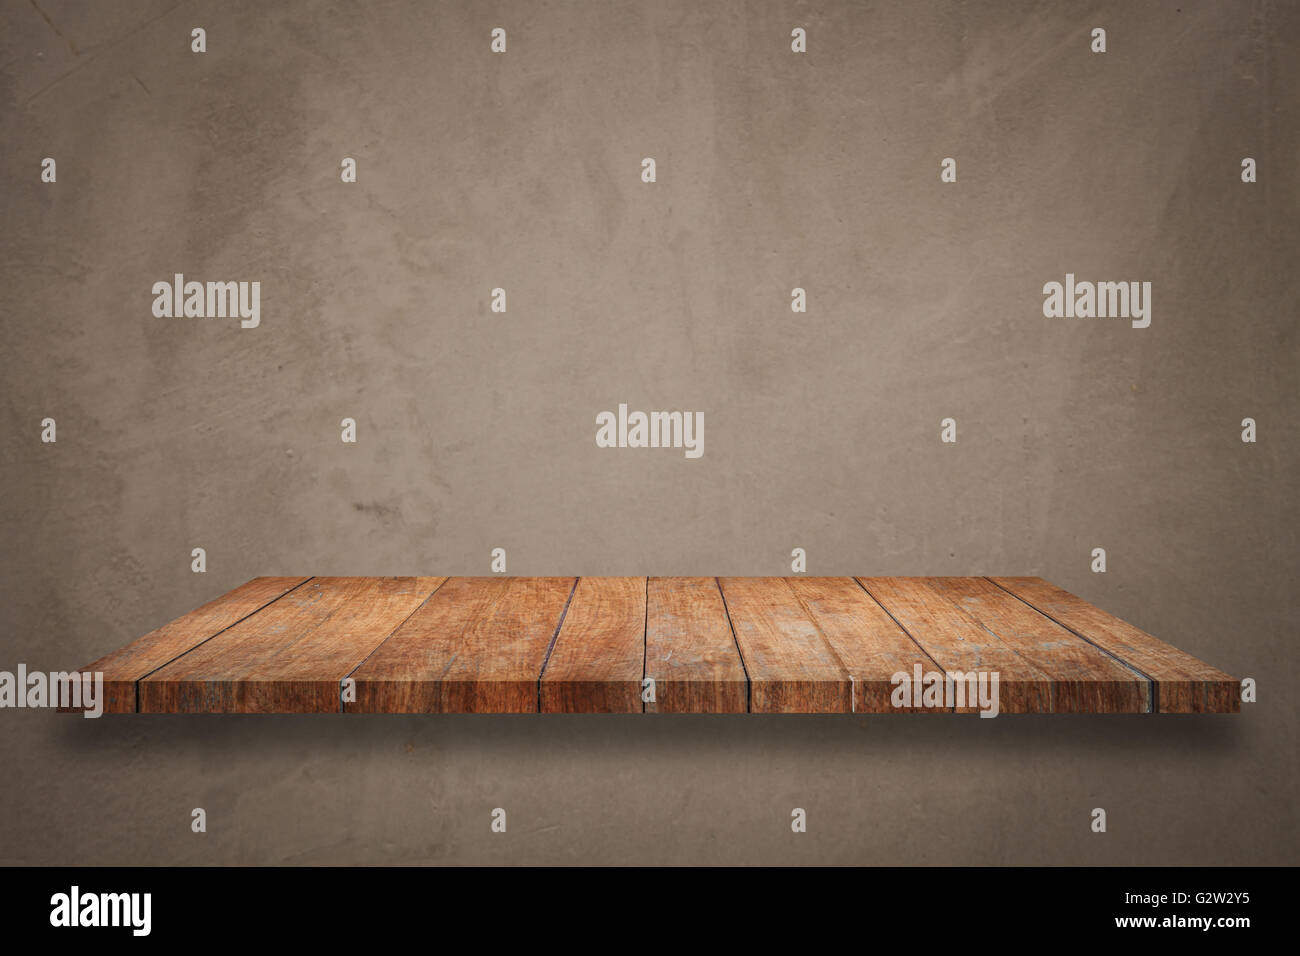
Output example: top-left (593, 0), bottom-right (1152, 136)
top-left (68, 576), bottom-right (1240, 714)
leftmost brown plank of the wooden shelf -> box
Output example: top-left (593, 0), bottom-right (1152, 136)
top-left (73, 578), bottom-right (308, 714)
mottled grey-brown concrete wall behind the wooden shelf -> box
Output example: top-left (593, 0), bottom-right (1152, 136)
top-left (0, 0), bottom-right (1300, 864)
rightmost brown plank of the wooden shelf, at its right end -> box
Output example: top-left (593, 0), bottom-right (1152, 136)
top-left (989, 578), bottom-right (1242, 714)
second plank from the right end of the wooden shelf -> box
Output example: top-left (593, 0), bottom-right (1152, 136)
top-left (930, 578), bottom-right (1152, 714)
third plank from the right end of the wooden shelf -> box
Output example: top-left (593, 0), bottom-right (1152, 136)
top-left (858, 578), bottom-right (1052, 713)
